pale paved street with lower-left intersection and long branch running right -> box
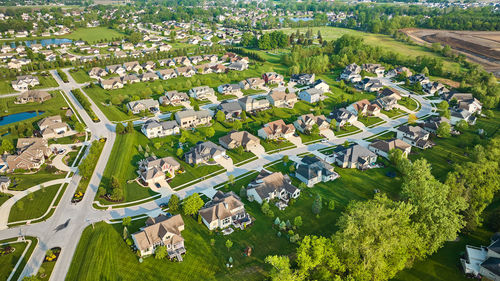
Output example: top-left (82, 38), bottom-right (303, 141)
top-left (0, 69), bottom-right (432, 281)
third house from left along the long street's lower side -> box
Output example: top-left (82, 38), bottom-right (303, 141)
top-left (247, 170), bottom-right (300, 206)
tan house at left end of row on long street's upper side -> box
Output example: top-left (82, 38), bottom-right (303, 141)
top-left (138, 156), bottom-right (181, 186)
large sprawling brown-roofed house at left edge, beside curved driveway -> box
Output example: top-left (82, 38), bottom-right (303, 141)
top-left (5, 138), bottom-right (52, 172)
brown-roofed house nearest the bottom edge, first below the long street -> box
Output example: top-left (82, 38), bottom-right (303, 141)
top-left (132, 215), bottom-right (186, 261)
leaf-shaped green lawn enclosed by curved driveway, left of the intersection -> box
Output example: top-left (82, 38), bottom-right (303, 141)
top-left (9, 185), bottom-right (61, 222)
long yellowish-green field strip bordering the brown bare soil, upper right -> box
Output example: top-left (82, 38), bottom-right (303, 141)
top-left (282, 26), bottom-right (460, 71)
